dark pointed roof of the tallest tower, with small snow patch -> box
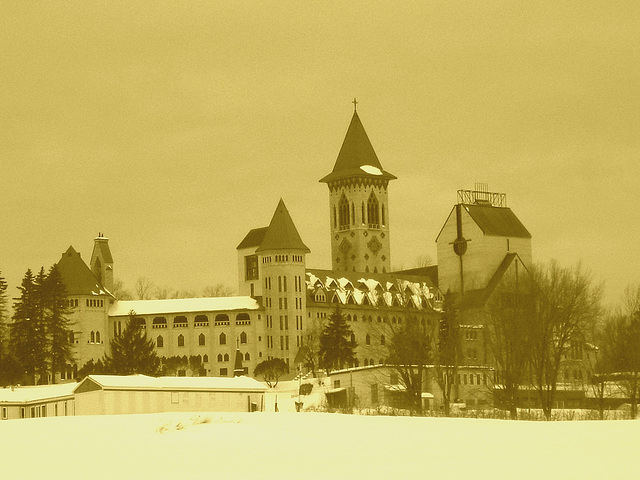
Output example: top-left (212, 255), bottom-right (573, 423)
top-left (320, 111), bottom-right (396, 183)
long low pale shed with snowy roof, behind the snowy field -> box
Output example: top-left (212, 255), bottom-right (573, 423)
top-left (74, 375), bottom-right (267, 415)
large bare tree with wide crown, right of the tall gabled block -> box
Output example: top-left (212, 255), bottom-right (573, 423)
top-left (531, 262), bottom-right (602, 420)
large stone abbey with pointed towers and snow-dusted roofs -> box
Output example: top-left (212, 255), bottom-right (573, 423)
top-left (58, 111), bottom-right (532, 398)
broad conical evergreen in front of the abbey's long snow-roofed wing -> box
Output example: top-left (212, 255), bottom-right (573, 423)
top-left (104, 310), bottom-right (160, 375)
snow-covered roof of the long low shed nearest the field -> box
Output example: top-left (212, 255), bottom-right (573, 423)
top-left (78, 375), bottom-right (267, 391)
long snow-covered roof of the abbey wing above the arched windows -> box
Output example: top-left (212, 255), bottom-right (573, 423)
top-left (109, 297), bottom-right (260, 317)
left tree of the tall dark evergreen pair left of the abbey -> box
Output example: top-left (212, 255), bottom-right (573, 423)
top-left (10, 269), bottom-right (46, 383)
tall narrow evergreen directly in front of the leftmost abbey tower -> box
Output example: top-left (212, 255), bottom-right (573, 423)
top-left (44, 265), bottom-right (73, 383)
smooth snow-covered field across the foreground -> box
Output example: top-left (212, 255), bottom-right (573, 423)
top-left (0, 412), bottom-right (640, 480)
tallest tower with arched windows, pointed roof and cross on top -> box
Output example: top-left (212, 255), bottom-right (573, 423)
top-left (320, 99), bottom-right (396, 273)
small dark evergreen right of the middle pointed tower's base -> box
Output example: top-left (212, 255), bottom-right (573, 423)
top-left (319, 305), bottom-right (356, 370)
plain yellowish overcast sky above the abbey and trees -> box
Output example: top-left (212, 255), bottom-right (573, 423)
top-left (0, 0), bottom-right (640, 303)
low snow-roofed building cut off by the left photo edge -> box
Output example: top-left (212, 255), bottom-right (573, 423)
top-left (0, 382), bottom-right (78, 420)
